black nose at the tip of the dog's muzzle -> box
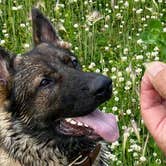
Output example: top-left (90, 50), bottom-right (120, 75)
top-left (89, 75), bottom-right (112, 99)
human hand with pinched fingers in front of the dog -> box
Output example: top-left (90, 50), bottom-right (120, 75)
top-left (140, 62), bottom-right (166, 154)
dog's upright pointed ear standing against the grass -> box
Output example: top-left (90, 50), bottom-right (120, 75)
top-left (32, 8), bottom-right (63, 47)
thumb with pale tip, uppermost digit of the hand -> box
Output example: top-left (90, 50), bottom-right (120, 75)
top-left (145, 62), bottom-right (166, 99)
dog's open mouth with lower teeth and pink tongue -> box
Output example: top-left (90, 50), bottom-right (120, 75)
top-left (55, 109), bottom-right (119, 142)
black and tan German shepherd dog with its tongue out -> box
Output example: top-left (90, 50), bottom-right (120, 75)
top-left (0, 8), bottom-right (119, 166)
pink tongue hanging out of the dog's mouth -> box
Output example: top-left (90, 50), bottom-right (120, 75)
top-left (73, 109), bottom-right (119, 142)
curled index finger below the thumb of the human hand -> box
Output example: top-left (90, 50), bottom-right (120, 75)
top-left (140, 65), bottom-right (166, 153)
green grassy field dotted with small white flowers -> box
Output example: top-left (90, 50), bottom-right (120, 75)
top-left (0, 0), bottom-right (166, 166)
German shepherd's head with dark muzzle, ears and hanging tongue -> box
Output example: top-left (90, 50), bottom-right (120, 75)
top-left (0, 9), bottom-right (118, 163)
